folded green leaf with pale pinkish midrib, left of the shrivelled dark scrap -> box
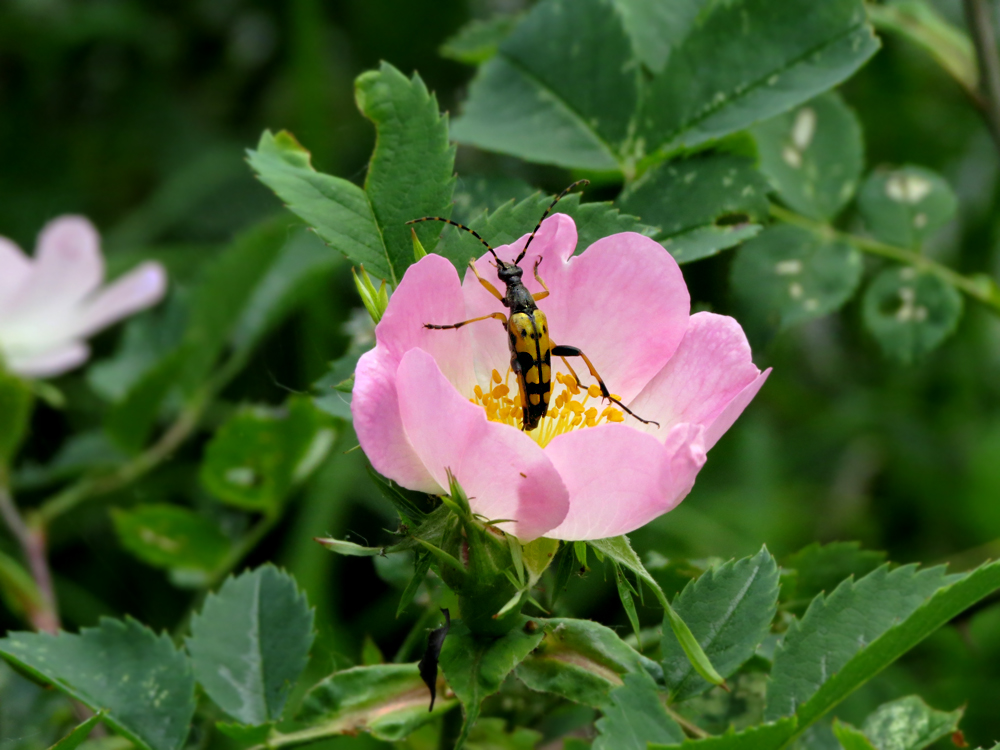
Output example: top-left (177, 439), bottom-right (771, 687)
top-left (296, 664), bottom-right (455, 742)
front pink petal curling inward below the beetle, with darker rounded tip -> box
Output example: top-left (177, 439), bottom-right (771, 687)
top-left (396, 349), bottom-right (569, 542)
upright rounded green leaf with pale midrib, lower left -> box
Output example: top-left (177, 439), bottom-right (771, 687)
top-left (185, 565), bottom-right (315, 724)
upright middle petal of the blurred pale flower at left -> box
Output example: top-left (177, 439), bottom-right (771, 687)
top-left (4, 216), bottom-right (104, 320)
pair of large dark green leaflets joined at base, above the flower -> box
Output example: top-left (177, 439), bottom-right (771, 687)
top-left (454, 0), bottom-right (878, 175)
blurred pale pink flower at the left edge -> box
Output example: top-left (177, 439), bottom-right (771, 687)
top-left (0, 216), bottom-right (166, 377)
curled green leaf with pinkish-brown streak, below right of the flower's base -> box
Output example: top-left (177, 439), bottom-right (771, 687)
top-left (516, 618), bottom-right (650, 709)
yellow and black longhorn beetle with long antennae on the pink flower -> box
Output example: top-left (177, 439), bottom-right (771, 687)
top-left (406, 180), bottom-right (660, 432)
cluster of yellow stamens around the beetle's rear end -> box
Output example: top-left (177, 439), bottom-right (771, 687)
top-left (469, 368), bottom-right (625, 448)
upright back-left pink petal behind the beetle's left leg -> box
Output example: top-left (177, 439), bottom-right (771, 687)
top-left (375, 254), bottom-right (478, 396)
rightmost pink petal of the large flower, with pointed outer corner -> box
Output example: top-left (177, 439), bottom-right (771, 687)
top-left (629, 312), bottom-right (770, 450)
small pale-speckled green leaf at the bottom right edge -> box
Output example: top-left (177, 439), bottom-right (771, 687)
top-left (861, 695), bottom-right (964, 750)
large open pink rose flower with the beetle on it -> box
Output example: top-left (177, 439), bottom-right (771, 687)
top-left (351, 214), bottom-right (770, 542)
